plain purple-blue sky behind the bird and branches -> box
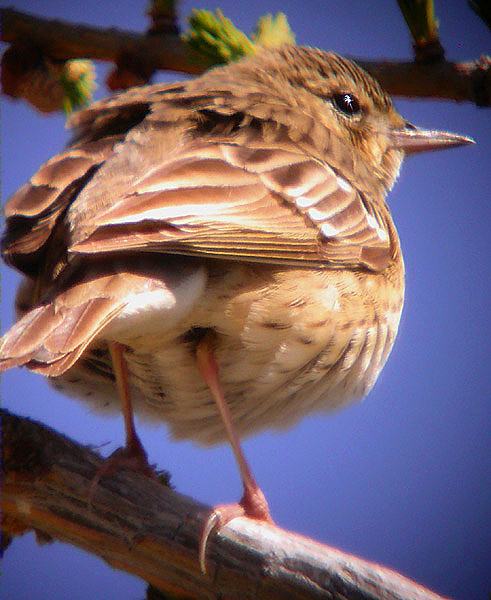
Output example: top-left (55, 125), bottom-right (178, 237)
top-left (1, 0), bottom-right (491, 600)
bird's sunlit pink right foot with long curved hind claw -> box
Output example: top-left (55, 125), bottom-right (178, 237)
top-left (199, 487), bottom-right (274, 574)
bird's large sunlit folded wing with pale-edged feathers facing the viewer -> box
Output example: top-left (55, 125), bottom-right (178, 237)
top-left (70, 132), bottom-right (391, 271)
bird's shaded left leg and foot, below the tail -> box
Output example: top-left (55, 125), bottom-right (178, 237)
top-left (90, 342), bottom-right (157, 498)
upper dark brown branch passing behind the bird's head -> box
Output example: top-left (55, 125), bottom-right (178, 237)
top-left (0, 9), bottom-right (491, 106)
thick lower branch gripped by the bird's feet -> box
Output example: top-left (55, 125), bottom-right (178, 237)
top-left (1, 411), bottom-right (441, 600)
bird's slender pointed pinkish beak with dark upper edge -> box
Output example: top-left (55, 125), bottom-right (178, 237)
top-left (390, 123), bottom-right (475, 154)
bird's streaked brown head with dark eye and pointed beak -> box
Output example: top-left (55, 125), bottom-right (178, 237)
top-left (199, 46), bottom-right (472, 192)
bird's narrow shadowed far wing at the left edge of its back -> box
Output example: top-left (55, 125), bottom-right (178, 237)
top-left (2, 84), bottom-right (182, 276)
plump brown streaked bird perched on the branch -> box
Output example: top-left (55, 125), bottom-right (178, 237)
top-left (0, 46), bottom-right (472, 558)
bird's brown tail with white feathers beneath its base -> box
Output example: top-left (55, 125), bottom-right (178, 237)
top-left (0, 255), bottom-right (203, 377)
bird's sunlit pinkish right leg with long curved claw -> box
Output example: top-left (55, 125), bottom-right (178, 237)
top-left (196, 335), bottom-right (273, 573)
